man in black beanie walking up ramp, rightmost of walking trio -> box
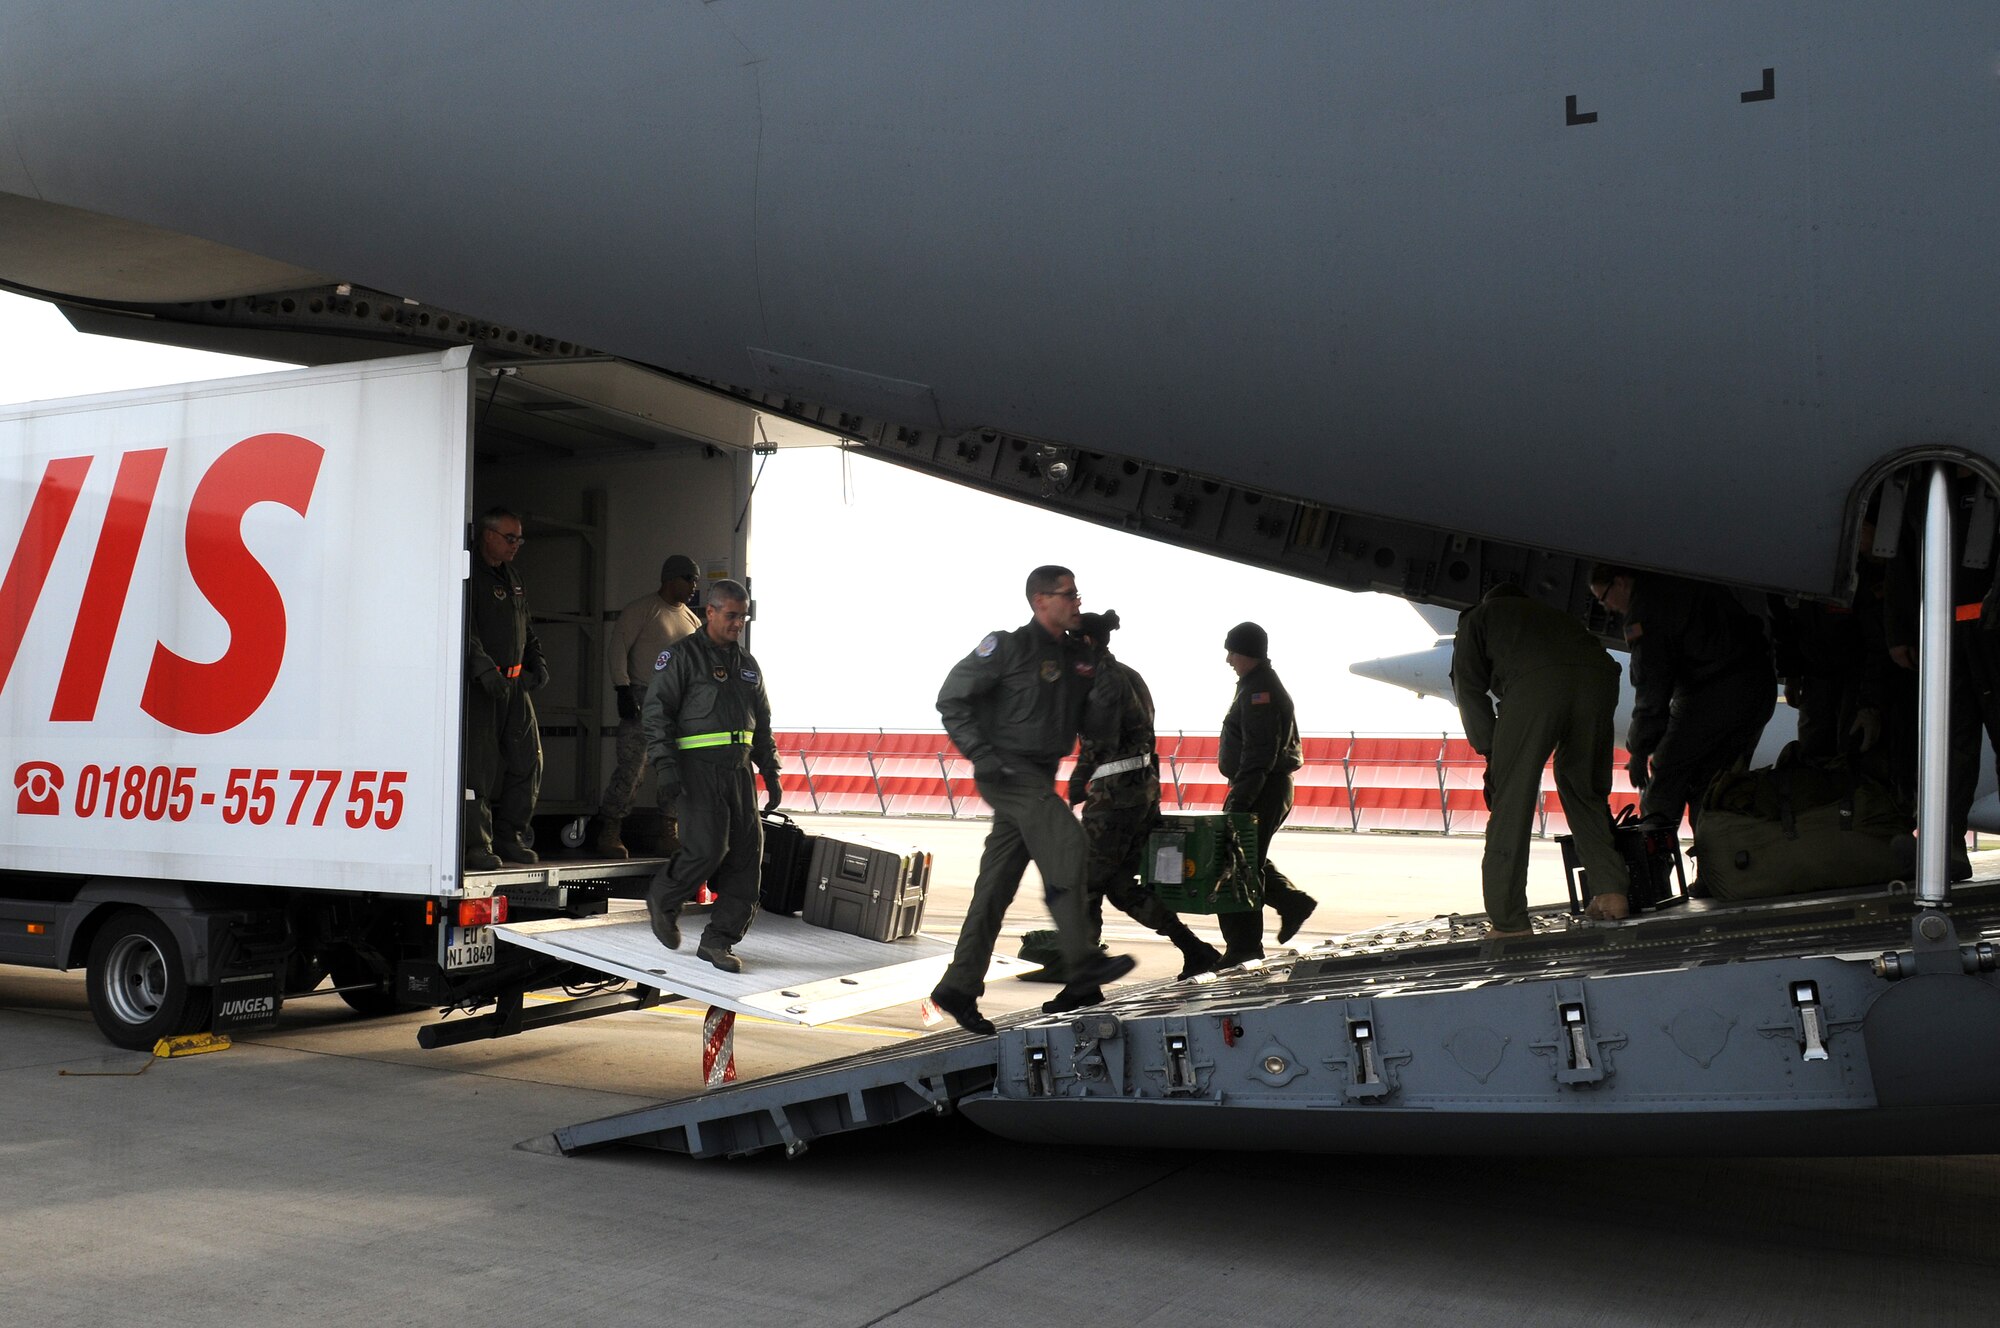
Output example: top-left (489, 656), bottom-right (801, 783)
top-left (1216, 622), bottom-right (1320, 966)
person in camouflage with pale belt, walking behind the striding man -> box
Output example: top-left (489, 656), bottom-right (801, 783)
top-left (1042, 612), bottom-right (1222, 1014)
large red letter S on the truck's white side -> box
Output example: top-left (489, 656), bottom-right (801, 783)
top-left (138, 434), bottom-right (326, 734)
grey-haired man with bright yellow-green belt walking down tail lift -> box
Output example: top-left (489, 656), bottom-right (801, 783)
top-left (640, 580), bottom-right (784, 972)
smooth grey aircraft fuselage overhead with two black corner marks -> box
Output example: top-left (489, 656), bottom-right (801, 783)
top-left (0, 0), bottom-right (2000, 592)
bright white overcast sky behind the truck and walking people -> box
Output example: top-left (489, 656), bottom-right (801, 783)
top-left (0, 294), bottom-right (1458, 734)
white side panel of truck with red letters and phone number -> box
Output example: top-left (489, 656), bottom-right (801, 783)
top-left (0, 352), bottom-right (468, 894)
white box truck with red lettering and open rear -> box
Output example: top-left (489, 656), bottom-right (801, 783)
top-left (0, 348), bottom-right (780, 1048)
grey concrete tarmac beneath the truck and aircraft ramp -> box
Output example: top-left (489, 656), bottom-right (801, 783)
top-left (0, 818), bottom-right (2000, 1328)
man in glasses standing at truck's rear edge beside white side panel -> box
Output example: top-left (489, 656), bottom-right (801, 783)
top-left (464, 508), bottom-right (548, 872)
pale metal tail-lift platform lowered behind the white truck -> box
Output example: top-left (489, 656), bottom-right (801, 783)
top-left (494, 908), bottom-right (1040, 1028)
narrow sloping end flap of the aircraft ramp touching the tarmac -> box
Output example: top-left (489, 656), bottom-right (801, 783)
top-left (544, 1032), bottom-right (1000, 1158)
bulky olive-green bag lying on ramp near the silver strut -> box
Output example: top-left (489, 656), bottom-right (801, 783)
top-left (1692, 744), bottom-right (1916, 900)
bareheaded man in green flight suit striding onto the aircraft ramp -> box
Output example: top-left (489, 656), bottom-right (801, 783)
top-left (930, 566), bottom-right (1134, 1034)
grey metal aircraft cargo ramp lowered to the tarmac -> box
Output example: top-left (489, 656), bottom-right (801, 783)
top-left (554, 880), bottom-right (2000, 1158)
